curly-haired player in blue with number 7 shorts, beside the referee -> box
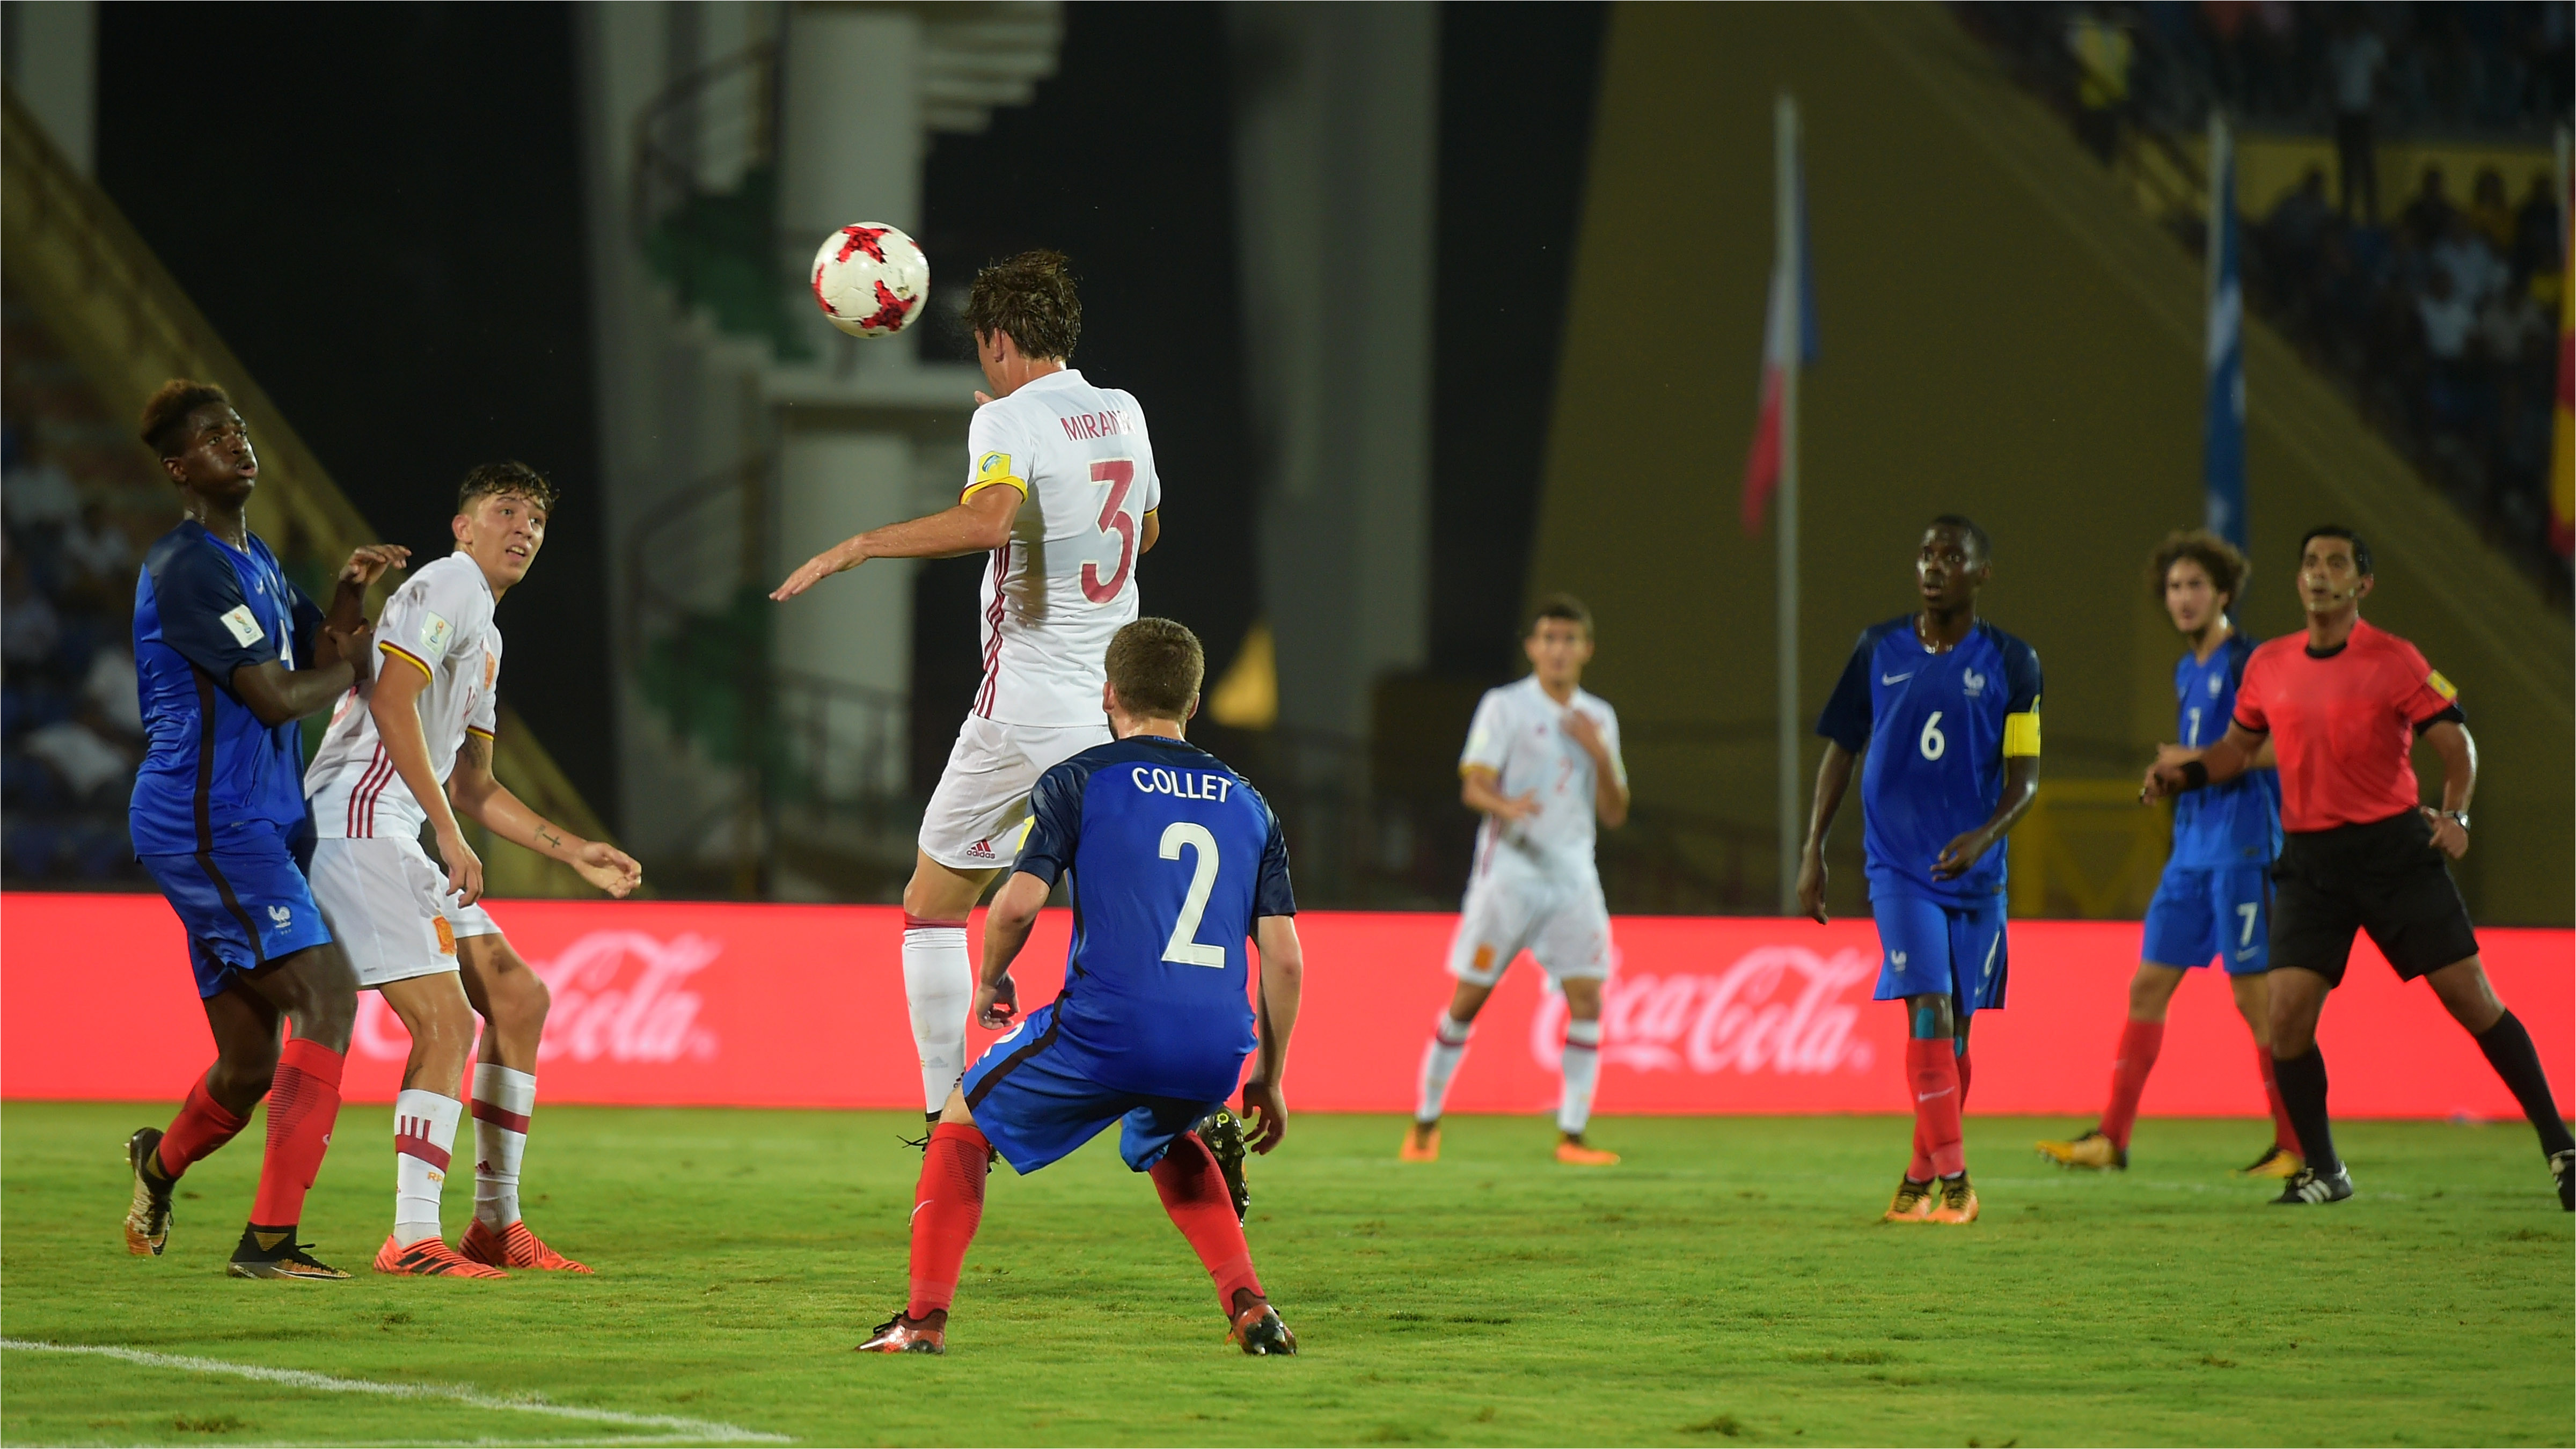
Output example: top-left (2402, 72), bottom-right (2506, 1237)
top-left (2038, 529), bottom-right (2306, 1179)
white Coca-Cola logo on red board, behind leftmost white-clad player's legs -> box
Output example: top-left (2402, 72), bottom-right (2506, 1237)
top-left (350, 931), bottom-right (724, 1062)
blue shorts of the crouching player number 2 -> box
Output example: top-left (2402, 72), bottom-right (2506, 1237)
top-left (963, 1003), bottom-right (1226, 1173)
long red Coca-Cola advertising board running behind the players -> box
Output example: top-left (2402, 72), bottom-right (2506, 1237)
top-left (0, 892), bottom-right (2576, 1119)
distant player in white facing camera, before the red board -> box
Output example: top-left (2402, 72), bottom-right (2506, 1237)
top-left (1396, 593), bottom-right (1628, 1168)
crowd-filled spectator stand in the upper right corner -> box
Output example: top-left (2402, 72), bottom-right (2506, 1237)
top-left (1958, 3), bottom-right (2576, 592)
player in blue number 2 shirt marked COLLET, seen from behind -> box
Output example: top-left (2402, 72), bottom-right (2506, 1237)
top-left (860, 619), bottom-right (1306, 1356)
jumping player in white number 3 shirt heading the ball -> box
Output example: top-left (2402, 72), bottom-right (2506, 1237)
top-left (770, 250), bottom-right (1162, 1122)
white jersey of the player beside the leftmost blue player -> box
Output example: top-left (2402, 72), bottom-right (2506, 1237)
top-left (304, 554), bottom-right (500, 840)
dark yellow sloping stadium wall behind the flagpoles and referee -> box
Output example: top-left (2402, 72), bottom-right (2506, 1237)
top-left (1527, 5), bottom-right (2576, 923)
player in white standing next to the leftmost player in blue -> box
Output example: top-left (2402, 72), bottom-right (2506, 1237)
top-left (304, 464), bottom-right (644, 1279)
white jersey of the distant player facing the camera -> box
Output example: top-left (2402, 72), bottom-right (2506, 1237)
top-left (1458, 676), bottom-right (1628, 879)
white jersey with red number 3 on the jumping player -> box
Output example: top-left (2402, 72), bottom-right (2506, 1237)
top-left (963, 369), bottom-right (1162, 724)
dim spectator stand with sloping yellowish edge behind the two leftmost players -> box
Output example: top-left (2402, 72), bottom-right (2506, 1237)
top-left (0, 93), bottom-right (608, 895)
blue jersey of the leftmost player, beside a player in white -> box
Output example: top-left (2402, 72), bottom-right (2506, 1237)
top-left (126, 518), bottom-right (322, 856)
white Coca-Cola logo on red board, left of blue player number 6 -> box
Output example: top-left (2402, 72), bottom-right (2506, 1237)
top-left (1530, 946), bottom-right (1878, 1075)
